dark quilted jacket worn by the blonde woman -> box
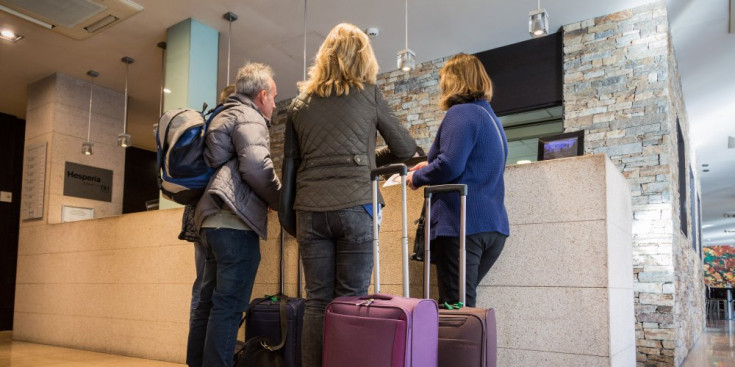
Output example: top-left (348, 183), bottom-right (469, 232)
top-left (279, 84), bottom-right (416, 215)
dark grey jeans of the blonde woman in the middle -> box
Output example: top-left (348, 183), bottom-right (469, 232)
top-left (296, 206), bottom-right (373, 367)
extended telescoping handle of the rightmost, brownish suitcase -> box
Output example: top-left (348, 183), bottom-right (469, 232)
top-left (424, 184), bottom-right (467, 304)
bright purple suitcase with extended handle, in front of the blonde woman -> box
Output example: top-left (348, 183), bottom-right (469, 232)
top-left (322, 164), bottom-right (439, 367)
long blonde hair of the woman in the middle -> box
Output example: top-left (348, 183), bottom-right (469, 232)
top-left (298, 23), bottom-right (378, 97)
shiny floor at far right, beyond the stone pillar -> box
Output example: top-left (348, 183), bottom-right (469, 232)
top-left (680, 318), bottom-right (735, 367)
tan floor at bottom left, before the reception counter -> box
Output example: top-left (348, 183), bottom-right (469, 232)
top-left (0, 332), bottom-right (185, 367)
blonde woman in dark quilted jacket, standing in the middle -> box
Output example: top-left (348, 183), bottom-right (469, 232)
top-left (279, 23), bottom-right (416, 367)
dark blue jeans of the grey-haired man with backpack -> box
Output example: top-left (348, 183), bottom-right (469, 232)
top-left (186, 228), bottom-right (260, 367)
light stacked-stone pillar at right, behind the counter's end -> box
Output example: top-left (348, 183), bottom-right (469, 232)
top-left (563, 2), bottom-right (703, 366)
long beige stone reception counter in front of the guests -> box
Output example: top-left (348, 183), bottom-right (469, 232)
top-left (13, 155), bottom-right (635, 367)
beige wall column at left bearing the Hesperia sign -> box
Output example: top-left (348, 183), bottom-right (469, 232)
top-left (21, 73), bottom-right (125, 227)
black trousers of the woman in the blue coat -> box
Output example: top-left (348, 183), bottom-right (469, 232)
top-left (431, 232), bottom-right (508, 307)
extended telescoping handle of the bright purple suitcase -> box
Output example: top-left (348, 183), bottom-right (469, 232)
top-left (370, 163), bottom-right (409, 297)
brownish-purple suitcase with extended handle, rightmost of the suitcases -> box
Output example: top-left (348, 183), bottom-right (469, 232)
top-left (424, 184), bottom-right (498, 367)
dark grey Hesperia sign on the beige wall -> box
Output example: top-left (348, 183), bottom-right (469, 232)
top-left (64, 162), bottom-right (112, 202)
